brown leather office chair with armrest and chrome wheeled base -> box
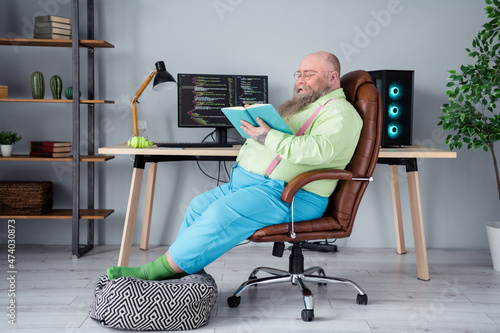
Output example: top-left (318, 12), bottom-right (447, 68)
top-left (227, 70), bottom-right (383, 321)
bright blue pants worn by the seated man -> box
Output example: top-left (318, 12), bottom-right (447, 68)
top-left (169, 165), bottom-right (328, 274)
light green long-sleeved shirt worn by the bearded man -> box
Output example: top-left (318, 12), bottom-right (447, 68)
top-left (237, 88), bottom-right (363, 197)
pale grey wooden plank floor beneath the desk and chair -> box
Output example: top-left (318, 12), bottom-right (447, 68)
top-left (0, 244), bottom-right (500, 333)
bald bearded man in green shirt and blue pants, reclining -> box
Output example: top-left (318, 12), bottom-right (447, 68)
top-left (107, 52), bottom-right (362, 280)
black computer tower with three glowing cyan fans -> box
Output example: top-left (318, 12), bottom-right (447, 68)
top-left (368, 70), bottom-right (414, 147)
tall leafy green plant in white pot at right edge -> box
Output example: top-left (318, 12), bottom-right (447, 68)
top-left (438, 0), bottom-right (500, 271)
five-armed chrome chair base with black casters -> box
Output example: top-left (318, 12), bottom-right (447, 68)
top-left (227, 243), bottom-right (368, 321)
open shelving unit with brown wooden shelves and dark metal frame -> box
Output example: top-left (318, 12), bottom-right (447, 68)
top-left (0, 0), bottom-right (114, 258)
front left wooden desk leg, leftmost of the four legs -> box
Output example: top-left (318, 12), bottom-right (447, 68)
top-left (118, 168), bottom-right (144, 266)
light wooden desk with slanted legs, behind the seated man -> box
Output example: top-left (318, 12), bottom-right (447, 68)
top-left (99, 143), bottom-right (457, 280)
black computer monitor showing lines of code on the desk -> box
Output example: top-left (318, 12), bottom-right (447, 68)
top-left (177, 73), bottom-right (268, 144)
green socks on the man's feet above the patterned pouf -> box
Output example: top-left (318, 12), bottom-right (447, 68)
top-left (108, 254), bottom-right (182, 281)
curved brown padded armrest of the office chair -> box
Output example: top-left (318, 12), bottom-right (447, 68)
top-left (281, 169), bottom-right (352, 203)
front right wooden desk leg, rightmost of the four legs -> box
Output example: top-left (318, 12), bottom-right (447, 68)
top-left (406, 171), bottom-right (430, 281)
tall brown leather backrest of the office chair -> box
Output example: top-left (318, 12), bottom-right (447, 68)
top-left (325, 70), bottom-right (383, 236)
